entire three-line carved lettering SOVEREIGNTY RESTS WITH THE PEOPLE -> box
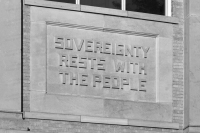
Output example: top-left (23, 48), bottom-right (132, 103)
top-left (54, 37), bottom-right (150, 92)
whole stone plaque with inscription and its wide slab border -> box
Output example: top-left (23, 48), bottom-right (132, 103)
top-left (30, 7), bottom-right (172, 122)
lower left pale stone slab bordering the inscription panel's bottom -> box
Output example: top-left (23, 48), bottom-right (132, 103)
top-left (30, 91), bottom-right (103, 116)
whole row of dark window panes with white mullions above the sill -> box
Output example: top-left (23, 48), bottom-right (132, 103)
top-left (46, 0), bottom-right (171, 16)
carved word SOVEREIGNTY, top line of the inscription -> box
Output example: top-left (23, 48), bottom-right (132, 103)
top-left (54, 37), bottom-right (150, 58)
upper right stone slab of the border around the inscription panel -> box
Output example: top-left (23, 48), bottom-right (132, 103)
top-left (104, 16), bottom-right (173, 38)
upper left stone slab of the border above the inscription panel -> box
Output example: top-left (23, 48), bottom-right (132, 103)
top-left (31, 7), bottom-right (104, 27)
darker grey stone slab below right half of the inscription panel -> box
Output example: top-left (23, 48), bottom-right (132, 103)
top-left (104, 100), bottom-right (172, 122)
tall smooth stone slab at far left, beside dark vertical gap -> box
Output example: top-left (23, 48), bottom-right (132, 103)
top-left (0, 0), bottom-right (21, 111)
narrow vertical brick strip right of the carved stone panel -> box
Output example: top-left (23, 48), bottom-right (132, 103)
top-left (172, 0), bottom-right (184, 129)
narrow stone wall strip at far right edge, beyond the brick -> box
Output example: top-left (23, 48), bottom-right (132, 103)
top-left (190, 16), bottom-right (200, 125)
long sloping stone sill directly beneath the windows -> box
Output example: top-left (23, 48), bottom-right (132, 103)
top-left (24, 0), bottom-right (179, 24)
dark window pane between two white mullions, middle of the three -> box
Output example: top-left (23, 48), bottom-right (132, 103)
top-left (80, 0), bottom-right (121, 9)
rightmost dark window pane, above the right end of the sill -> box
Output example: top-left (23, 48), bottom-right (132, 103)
top-left (126, 0), bottom-right (165, 15)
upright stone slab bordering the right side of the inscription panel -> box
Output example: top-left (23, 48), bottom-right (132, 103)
top-left (157, 37), bottom-right (173, 102)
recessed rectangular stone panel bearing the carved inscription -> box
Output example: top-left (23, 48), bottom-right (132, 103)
top-left (46, 24), bottom-right (158, 102)
